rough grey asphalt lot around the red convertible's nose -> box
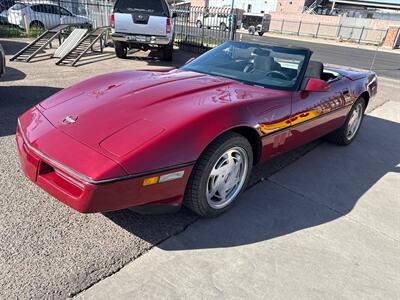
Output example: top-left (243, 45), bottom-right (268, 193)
top-left (0, 40), bottom-right (398, 299)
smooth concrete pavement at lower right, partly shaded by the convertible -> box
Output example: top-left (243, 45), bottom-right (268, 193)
top-left (76, 102), bottom-right (400, 299)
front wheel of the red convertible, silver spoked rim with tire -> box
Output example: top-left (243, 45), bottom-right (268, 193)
top-left (184, 133), bottom-right (253, 217)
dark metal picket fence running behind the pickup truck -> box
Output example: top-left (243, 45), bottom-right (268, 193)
top-left (0, 0), bottom-right (240, 50)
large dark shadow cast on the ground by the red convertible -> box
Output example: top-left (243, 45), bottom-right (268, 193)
top-left (105, 116), bottom-right (400, 250)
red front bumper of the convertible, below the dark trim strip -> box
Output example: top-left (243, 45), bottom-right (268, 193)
top-left (16, 116), bottom-right (192, 213)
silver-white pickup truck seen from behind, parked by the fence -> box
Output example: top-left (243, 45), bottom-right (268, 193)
top-left (111, 0), bottom-right (175, 60)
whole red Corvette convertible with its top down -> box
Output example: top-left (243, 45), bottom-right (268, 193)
top-left (16, 42), bottom-right (377, 216)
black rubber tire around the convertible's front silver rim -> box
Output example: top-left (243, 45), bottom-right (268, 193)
top-left (183, 132), bottom-right (253, 217)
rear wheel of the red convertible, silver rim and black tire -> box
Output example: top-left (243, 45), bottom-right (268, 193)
top-left (326, 97), bottom-right (366, 145)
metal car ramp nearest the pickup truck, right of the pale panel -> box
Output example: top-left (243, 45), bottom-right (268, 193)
top-left (56, 27), bottom-right (109, 66)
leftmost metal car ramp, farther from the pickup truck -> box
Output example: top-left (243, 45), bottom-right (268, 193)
top-left (10, 24), bottom-right (70, 62)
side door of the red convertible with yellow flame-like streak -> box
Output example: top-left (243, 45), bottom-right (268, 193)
top-left (286, 77), bottom-right (352, 150)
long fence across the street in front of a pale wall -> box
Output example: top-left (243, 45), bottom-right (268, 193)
top-left (270, 19), bottom-right (387, 46)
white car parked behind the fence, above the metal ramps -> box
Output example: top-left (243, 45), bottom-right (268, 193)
top-left (8, 3), bottom-right (90, 29)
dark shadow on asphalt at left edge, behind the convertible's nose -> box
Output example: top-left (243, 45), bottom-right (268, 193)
top-left (0, 84), bottom-right (61, 137)
